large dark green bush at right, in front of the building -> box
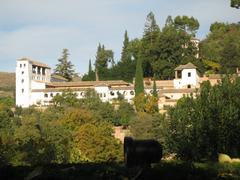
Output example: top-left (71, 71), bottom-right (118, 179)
top-left (165, 77), bottom-right (240, 160)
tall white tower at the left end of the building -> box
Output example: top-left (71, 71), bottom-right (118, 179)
top-left (16, 58), bottom-right (51, 107)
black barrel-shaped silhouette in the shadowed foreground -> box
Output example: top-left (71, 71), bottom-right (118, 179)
top-left (124, 137), bottom-right (162, 167)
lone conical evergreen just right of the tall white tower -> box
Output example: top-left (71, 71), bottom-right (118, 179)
top-left (54, 49), bottom-right (75, 81)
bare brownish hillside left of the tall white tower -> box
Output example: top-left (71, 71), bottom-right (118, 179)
top-left (0, 72), bottom-right (15, 97)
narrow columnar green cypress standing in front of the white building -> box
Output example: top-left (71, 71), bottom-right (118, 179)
top-left (134, 58), bottom-right (144, 96)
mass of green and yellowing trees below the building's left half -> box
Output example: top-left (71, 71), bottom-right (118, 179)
top-left (0, 91), bottom-right (124, 166)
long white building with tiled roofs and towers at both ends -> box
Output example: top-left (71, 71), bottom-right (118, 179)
top-left (16, 58), bottom-right (221, 110)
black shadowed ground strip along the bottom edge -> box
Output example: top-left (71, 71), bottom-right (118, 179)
top-left (0, 161), bottom-right (240, 180)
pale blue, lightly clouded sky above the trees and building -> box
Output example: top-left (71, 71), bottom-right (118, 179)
top-left (0, 0), bottom-right (240, 75)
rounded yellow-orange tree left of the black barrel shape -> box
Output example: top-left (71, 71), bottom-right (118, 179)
top-left (74, 123), bottom-right (121, 162)
